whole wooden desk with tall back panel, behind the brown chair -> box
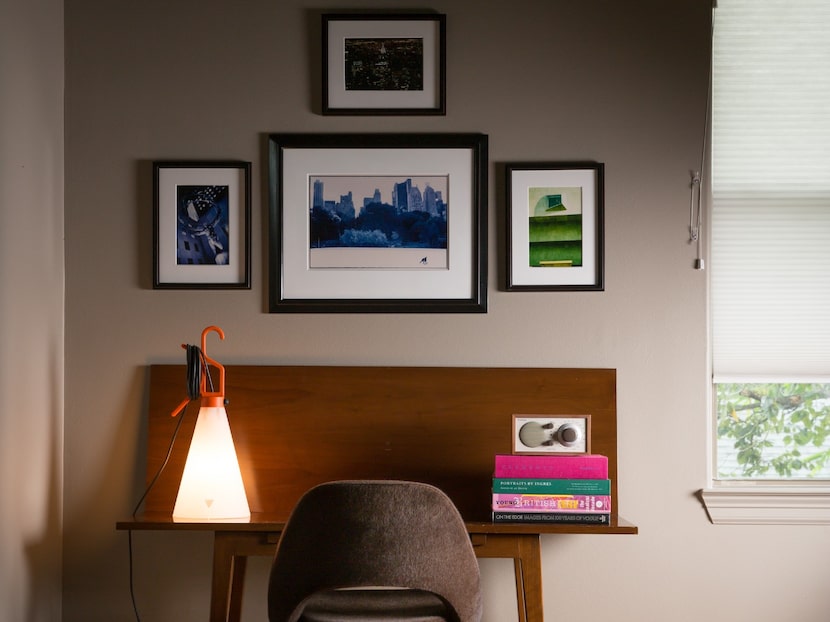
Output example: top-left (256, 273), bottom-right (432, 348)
top-left (123, 365), bottom-right (637, 622)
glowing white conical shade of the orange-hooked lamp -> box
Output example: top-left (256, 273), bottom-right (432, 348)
top-left (173, 405), bottom-right (251, 522)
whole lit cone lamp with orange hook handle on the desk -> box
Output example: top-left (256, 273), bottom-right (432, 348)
top-left (173, 326), bottom-right (251, 522)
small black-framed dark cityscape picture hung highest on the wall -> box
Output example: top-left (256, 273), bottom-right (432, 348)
top-left (323, 14), bottom-right (446, 115)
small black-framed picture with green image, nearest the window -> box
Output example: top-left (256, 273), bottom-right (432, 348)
top-left (506, 162), bottom-right (605, 291)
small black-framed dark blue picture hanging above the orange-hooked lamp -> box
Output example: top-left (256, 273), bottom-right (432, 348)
top-left (153, 161), bottom-right (251, 289)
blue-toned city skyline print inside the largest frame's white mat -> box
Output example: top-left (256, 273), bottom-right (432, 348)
top-left (308, 175), bottom-right (449, 269)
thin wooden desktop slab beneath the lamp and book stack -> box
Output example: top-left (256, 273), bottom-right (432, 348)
top-left (115, 513), bottom-right (639, 535)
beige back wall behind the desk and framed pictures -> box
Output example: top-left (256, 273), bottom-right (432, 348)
top-left (64, 0), bottom-right (830, 622)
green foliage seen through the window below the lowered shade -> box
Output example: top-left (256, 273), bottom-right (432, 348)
top-left (715, 383), bottom-right (830, 479)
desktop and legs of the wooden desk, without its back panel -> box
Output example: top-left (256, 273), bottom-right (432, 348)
top-left (117, 514), bottom-right (637, 622)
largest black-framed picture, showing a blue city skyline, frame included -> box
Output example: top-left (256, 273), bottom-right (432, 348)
top-left (269, 134), bottom-right (487, 313)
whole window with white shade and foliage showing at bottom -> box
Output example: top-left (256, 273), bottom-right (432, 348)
top-left (704, 0), bottom-right (830, 522)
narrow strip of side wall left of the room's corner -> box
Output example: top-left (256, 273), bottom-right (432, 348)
top-left (0, 0), bottom-right (64, 622)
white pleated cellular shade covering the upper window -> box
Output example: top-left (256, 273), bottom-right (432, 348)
top-left (710, 0), bottom-right (830, 382)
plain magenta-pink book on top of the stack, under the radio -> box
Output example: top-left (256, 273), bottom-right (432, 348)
top-left (494, 454), bottom-right (608, 479)
